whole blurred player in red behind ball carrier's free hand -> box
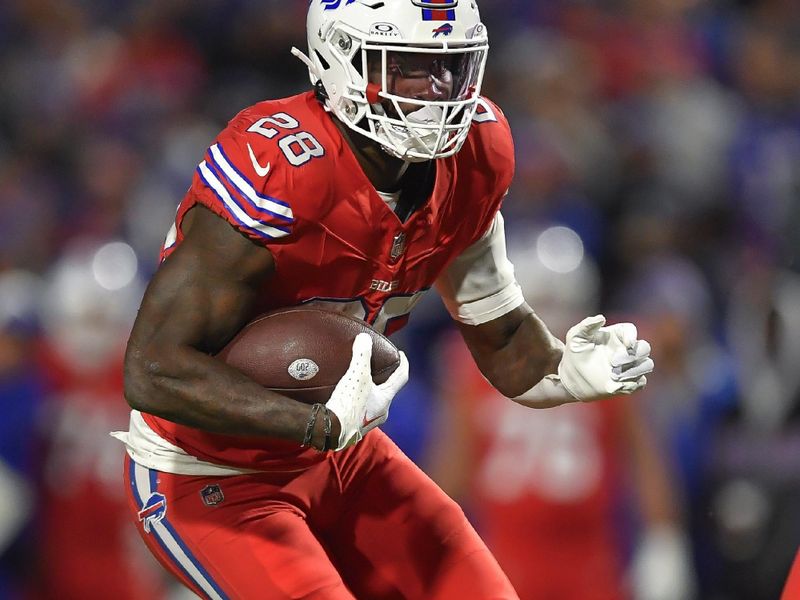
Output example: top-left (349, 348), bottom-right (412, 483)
top-left (429, 227), bottom-right (694, 600)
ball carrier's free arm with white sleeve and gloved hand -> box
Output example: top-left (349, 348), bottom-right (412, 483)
top-left (436, 214), bottom-right (653, 408)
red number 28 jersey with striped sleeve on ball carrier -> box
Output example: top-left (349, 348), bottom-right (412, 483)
top-left (145, 92), bottom-right (514, 469)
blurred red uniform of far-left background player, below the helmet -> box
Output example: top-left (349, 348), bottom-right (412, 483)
top-left (35, 347), bottom-right (166, 600)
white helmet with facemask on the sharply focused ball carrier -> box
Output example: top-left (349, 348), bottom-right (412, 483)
top-left (292, 0), bottom-right (489, 162)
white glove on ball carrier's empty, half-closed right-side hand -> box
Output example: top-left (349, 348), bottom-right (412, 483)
top-left (558, 315), bottom-right (654, 400)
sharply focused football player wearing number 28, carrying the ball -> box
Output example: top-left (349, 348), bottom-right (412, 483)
top-left (118, 0), bottom-right (653, 600)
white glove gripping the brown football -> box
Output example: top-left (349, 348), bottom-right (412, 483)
top-left (326, 333), bottom-right (408, 450)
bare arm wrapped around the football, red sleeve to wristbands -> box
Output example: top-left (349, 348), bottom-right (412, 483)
top-left (125, 206), bottom-right (339, 447)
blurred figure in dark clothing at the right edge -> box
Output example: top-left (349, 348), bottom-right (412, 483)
top-left (697, 260), bottom-right (800, 600)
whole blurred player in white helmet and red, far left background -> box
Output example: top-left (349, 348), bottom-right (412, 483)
top-left (29, 241), bottom-right (166, 600)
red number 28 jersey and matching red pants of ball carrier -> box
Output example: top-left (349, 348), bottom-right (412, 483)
top-left (126, 93), bottom-right (516, 600)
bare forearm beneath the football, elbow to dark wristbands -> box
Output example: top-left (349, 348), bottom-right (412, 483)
top-left (125, 346), bottom-right (337, 446)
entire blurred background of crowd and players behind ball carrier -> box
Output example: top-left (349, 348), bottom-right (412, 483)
top-left (0, 0), bottom-right (800, 600)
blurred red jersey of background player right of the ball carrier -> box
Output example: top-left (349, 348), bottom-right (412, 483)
top-left (444, 338), bottom-right (629, 600)
